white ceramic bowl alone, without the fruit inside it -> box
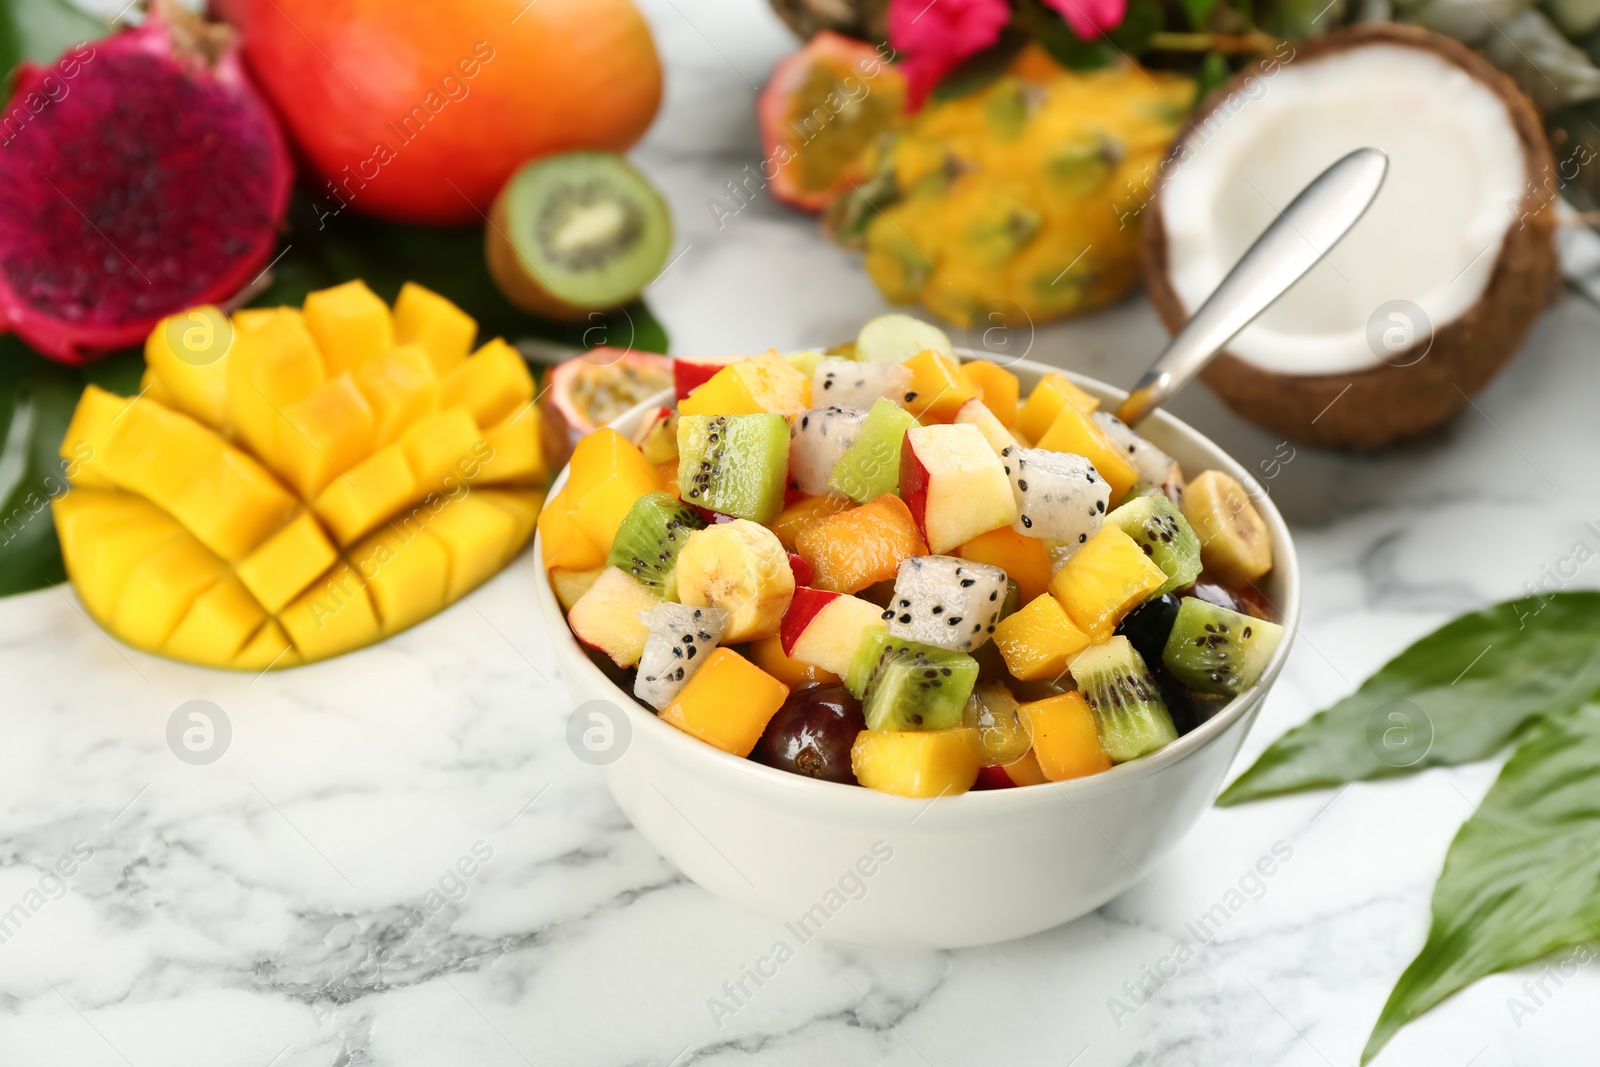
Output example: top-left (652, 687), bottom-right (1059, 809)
top-left (534, 362), bottom-right (1299, 947)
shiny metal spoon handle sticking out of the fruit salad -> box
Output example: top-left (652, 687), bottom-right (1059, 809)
top-left (1117, 149), bottom-right (1389, 426)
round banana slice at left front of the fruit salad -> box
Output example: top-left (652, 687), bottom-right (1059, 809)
top-left (677, 518), bottom-right (795, 645)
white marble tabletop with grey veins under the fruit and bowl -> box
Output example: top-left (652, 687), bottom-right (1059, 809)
top-left (0, 0), bottom-right (1600, 1067)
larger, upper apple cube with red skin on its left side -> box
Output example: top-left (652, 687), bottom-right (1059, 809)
top-left (899, 424), bottom-right (1016, 555)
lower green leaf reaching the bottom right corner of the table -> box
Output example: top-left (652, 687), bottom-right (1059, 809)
top-left (1362, 704), bottom-right (1600, 1064)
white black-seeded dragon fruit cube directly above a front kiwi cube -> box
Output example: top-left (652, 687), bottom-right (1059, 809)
top-left (883, 555), bottom-right (1006, 653)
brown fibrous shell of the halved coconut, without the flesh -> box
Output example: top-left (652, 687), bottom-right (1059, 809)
top-left (1144, 24), bottom-right (1558, 450)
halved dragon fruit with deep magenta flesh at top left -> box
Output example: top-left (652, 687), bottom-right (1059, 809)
top-left (0, 0), bottom-right (291, 363)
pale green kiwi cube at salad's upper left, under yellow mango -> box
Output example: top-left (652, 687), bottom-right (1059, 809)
top-left (678, 414), bottom-right (789, 525)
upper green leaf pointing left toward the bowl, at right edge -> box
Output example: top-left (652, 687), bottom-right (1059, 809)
top-left (1218, 592), bottom-right (1600, 806)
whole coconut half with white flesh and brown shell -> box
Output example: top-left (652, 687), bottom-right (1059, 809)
top-left (1144, 26), bottom-right (1557, 448)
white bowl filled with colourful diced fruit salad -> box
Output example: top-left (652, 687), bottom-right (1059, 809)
top-left (534, 315), bottom-right (1299, 953)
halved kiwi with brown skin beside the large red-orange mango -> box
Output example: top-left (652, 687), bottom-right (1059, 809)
top-left (483, 152), bottom-right (672, 320)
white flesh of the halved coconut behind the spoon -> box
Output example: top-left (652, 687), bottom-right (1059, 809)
top-left (1162, 45), bottom-right (1528, 374)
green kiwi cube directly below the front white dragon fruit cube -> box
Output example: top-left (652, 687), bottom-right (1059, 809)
top-left (850, 633), bottom-right (978, 729)
